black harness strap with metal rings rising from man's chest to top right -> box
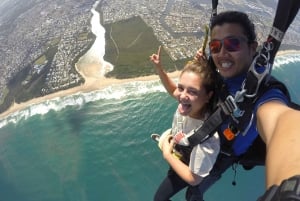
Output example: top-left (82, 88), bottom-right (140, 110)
top-left (233, 0), bottom-right (300, 143)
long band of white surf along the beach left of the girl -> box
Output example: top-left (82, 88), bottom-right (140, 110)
top-left (0, 80), bottom-right (169, 128)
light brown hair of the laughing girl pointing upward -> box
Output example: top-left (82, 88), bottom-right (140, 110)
top-left (180, 60), bottom-right (216, 114)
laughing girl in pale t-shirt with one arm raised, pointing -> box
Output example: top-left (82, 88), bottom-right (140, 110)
top-left (150, 47), bottom-right (220, 201)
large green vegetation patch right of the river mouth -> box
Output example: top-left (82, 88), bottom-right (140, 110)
top-left (104, 17), bottom-right (185, 79)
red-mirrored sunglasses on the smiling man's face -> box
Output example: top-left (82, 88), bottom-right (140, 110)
top-left (209, 36), bottom-right (247, 54)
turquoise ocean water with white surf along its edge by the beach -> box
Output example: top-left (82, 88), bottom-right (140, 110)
top-left (0, 52), bottom-right (300, 201)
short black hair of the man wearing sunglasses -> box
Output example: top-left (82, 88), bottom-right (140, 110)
top-left (211, 11), bottom-right (256, 43)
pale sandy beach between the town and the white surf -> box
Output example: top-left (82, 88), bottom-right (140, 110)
top-left (0, 50), bottom-right (300, 119)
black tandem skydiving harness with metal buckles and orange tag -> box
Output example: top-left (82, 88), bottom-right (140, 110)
top-left (188, 0), bottom-right (300, 151)
